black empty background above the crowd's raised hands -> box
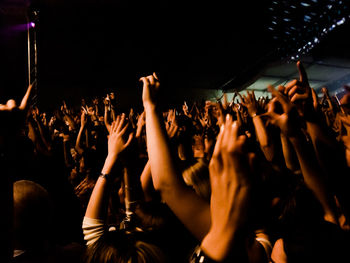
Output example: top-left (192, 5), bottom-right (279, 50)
top-left (0, 0), bottom-right (349, 108)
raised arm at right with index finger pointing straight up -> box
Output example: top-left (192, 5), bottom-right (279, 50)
top-left (286, 62), bottom-right (350, 222)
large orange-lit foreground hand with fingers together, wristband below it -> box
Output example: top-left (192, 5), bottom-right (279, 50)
top-left (201, 117), bottom-right (253, 262)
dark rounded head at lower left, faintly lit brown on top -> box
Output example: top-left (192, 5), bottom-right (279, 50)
top-left (13, 180), bottom-right (52, 249)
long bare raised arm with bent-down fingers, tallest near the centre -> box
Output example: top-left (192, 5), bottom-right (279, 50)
top-left (140, 74), bottom-right (210, 240)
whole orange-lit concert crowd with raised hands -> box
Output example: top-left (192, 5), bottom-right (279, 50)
top-left (0, 62), bottom-right (350, 263)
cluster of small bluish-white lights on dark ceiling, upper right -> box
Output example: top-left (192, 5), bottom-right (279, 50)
top-left (266, 0), bottom-right (350, 60)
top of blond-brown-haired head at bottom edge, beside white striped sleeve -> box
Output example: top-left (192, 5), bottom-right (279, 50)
top-left (85, 230), bottom-right (166, 263)
